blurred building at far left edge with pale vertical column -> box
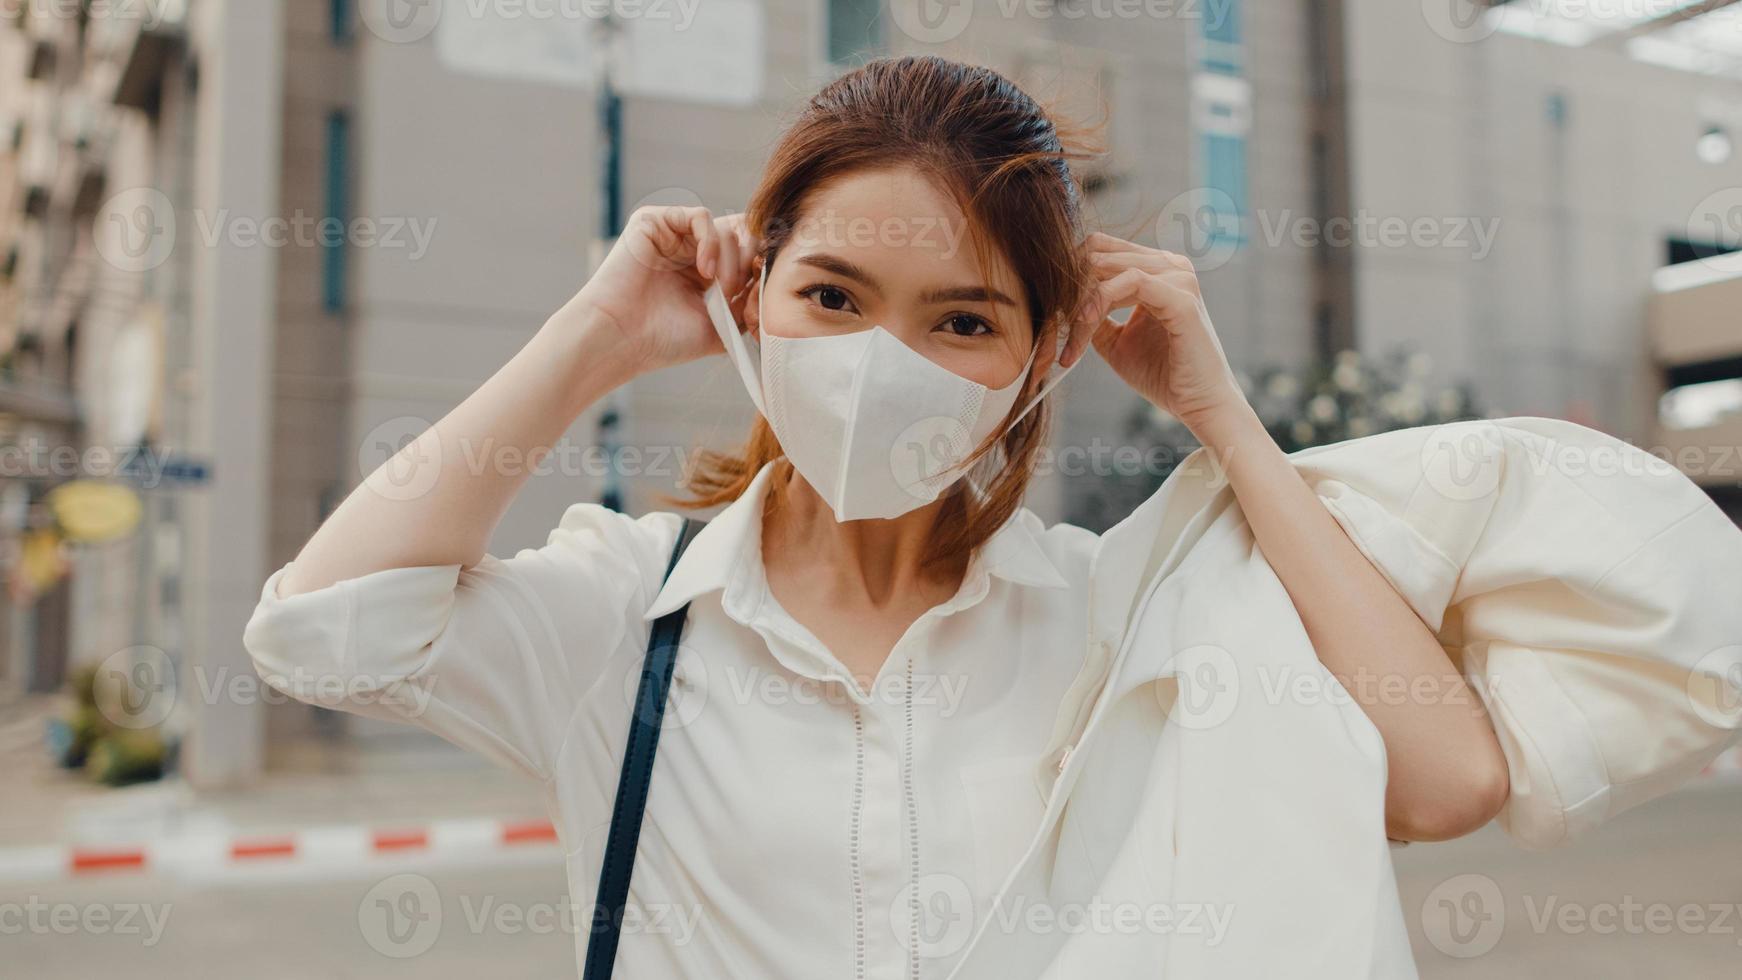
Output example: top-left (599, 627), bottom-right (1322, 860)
top-left (0, 0), bottom-right (284, 783)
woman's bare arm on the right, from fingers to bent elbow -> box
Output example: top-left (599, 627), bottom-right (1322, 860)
top-left (1080, 235), bottom-right (1510, 841)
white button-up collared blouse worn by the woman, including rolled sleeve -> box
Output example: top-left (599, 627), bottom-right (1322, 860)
top-left (246, 467), bottom-right (1097, 980)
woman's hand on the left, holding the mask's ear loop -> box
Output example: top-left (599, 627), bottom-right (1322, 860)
top-left (557, 205), bottom-right (756, 374)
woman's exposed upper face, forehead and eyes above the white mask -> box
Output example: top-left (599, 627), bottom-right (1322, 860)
top-left (746, 169), bottom-right (1033, 388)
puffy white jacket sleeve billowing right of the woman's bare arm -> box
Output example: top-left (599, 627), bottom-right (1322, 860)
top-left (1294, 418), bottom-right (1742, 848)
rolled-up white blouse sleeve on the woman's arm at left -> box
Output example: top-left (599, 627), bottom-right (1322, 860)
top-left (242, 503), bottom-right (678, 778)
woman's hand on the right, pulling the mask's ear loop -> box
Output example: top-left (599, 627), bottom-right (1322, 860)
top-left (1077, 232), bottom-right (1251, 439)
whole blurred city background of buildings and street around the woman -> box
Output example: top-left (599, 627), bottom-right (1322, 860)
top-left (0, 0), bottom-right (1742, 980)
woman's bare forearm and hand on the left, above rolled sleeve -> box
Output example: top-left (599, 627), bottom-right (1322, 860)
top-left (279, 207), bottom-right (751, 597)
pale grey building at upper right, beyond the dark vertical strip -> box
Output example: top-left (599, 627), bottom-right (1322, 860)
top-left (1347, 0), bottom-right (1742, 445)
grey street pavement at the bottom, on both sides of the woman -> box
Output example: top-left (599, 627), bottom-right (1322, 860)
top-left (0, 782), bottom-right (1742, 980)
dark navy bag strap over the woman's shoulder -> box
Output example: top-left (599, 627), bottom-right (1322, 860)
top-left (582, 517), bottom-right (707, 980)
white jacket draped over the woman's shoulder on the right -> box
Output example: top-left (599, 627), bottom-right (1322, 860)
top-left (951, 418), bottom-right (1742, 980)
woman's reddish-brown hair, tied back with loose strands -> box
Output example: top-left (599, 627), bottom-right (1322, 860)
top-left (679, 56), bottom-right (1090, 562)
